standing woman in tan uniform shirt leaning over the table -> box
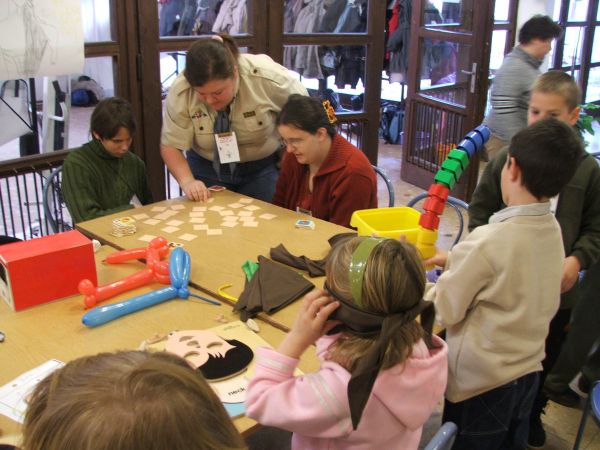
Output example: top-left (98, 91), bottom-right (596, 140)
top-left (161, 35), bottom-right (307, 201)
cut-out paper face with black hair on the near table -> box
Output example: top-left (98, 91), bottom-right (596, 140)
top-left (165, 330), bottom-right (254, 380)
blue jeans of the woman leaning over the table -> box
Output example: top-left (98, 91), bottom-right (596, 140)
top-left (187, 150), bottom-right (279, 202)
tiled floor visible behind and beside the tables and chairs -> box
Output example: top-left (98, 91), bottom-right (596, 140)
top-left (378, 141), bottom-right (600, 450)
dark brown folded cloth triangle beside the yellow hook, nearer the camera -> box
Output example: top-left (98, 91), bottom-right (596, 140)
top-left (234, 256), bottom-right (315, 321)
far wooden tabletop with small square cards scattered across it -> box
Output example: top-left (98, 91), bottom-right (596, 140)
top-left (77, 190), bottom-right (351, 330)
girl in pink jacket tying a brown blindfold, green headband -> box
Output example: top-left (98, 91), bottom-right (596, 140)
top-left (246, 237), bottom-right (448, 450)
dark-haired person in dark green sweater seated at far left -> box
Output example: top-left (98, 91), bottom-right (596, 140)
top-left (62, 97), bottom-right (152, 223)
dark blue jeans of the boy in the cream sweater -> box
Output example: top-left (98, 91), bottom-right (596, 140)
top-left (442, 372), bottom-right (539, 450)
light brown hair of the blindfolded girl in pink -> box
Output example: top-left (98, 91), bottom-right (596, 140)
top-left (325, 237), bottom-right (425, 373)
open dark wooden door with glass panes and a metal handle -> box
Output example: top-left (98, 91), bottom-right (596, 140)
top-left (401, 0), bottom-right (494, 200)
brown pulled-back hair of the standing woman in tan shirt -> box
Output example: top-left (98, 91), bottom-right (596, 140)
top-left (183, 34), bottom-right (240, 87)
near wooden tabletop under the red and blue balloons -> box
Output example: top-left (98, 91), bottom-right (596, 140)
top-left (0, 246), bottom-right (319, 434)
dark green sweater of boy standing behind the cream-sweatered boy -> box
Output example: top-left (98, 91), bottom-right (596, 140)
top-left (469, 147), bottom-right (600, 308)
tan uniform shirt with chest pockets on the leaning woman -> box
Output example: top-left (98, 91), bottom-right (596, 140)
top-left (161, 54), bottom-right (308, 162)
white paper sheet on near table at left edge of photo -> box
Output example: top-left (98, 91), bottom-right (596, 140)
top-left (0, 359), bottom-right (65, 423)
